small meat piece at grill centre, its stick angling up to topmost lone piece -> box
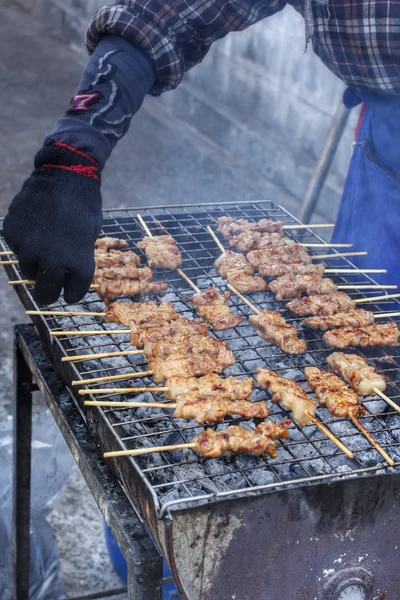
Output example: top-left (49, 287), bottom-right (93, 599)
top-left (187, 287), bottom-right (244, 331)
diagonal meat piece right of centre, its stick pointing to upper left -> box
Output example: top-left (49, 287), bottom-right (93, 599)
top-left (249, 308), bottom-right (307, 354)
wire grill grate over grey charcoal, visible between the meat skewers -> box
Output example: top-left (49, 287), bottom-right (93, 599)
top-left (2, 201), bottom-right (400, 516)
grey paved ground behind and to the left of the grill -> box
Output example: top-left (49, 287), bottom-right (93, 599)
top-left (0, 0), bottom-right (350, 600)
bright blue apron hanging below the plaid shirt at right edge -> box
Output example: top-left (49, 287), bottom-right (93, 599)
top-left (332, 89), bottom-right (400, 292)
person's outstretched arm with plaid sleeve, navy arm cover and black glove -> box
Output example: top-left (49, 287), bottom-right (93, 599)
top-left (4, 0), bottom-right (286, 304)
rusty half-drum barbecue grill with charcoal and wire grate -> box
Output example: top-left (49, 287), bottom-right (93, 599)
top-left (1, 201), bottom-right (400, 600)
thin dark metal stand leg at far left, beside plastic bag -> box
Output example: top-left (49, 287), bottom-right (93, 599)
top-left (13, 334), bottom-right (32, 600)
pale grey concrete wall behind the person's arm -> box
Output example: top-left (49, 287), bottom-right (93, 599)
top-left (10, 0), bottom-right (357, 220)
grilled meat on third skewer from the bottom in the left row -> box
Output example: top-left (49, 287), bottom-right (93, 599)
top-left (165, 373), bottom-right (253, 401)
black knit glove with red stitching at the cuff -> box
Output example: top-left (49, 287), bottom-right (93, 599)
top-left (4, 141), bottom-right (103, 304)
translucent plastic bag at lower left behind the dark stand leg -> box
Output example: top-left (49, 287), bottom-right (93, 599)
top-left (0, 411), bottom-right (73, 600)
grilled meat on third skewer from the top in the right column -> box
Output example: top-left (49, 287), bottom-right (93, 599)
top-left (246, 244), bottom-right (311, 277)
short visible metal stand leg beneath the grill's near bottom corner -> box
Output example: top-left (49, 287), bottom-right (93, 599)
top-left (127, 556), bottom-right (162, 600)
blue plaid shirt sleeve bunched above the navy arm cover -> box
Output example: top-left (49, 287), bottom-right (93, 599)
top-left (86, 0), bottom-right (286, 95)
